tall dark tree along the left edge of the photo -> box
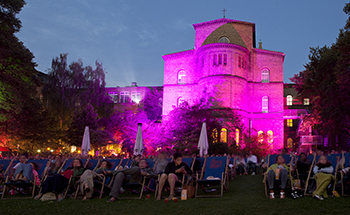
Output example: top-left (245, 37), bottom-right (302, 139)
top-left (0, 0), bottom-right (55, 150)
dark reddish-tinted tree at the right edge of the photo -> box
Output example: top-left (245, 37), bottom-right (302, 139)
top-left (291, 3), bottom-right (350, 147)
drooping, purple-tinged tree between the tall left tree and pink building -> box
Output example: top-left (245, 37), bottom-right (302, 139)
top-left (43, 54), bottom-right (113, 147)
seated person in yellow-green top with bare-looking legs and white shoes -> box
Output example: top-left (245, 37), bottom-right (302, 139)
top-left (267, 155), bottom-right (293, 199)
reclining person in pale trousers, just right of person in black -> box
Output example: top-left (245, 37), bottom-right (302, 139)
top-left (79, 160), bottom-right (112, 200)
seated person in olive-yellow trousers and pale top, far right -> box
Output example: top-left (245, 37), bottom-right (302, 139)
top-left (312, 155), bottom-right (334, 200)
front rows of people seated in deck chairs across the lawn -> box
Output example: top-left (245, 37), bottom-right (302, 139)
top-left (2, 150), bottom-right (350, 202)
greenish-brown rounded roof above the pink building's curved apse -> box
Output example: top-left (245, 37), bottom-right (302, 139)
top-left (202, 23), bottom-right (247, 48)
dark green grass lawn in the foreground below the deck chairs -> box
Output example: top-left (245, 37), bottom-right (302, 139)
top-left (0, 175), bottom-right (350, 215)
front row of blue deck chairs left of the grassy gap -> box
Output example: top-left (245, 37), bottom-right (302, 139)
top-left (0, 157), bottom-right (229, 199)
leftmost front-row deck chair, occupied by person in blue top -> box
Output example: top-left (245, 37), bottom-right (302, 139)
top-left (1, 160), bottom-right (49, 199)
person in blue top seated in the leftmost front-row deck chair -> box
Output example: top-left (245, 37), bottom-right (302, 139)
top-left (13, 154), bottom-right (33, 182)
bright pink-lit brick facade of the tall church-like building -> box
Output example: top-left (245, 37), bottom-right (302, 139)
top-left (163, 18), bottom-right (285, 149)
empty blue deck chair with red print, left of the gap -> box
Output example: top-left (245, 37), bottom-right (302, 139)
top-left (195, 157), bottom-right (229, 198)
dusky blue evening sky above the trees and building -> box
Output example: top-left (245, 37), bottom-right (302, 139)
top-left (17, 0), bottom-right (349, 86)
